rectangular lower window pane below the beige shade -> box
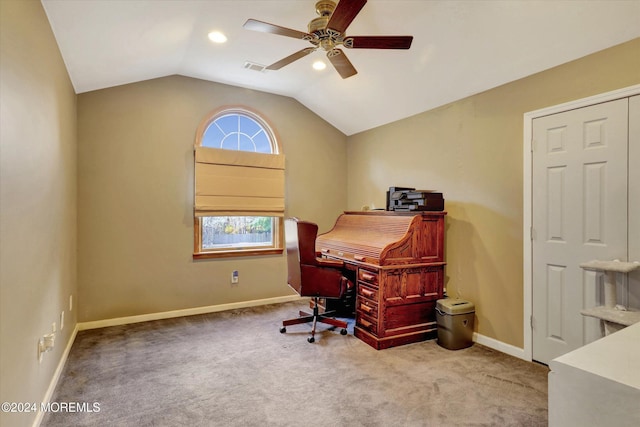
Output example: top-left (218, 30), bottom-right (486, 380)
top-left (201, 216), bottom-right (275, 250)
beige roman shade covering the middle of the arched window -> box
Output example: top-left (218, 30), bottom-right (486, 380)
top-left (195, 147), bottom-right (284, 216)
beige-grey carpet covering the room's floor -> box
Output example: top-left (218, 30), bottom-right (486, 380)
top-left (42, 303), bottom-right (548, 427)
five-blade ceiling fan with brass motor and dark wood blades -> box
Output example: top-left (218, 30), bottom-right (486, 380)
top-left (244, 0), bottom-right (413, 79)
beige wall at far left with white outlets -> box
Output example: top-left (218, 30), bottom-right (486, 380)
top-left (0, 0), bottom-right (77, 426)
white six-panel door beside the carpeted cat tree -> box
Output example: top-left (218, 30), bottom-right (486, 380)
top-left (532, 99), bottom-right (628, 363)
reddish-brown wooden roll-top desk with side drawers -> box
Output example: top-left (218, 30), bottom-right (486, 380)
top-left (316, 211), bottom-right (446, 350)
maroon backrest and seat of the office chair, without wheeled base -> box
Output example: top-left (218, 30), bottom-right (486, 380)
top-left (284, 218), bottom-right (344, 298)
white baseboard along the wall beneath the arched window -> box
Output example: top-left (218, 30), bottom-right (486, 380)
top-left (78, 294), bottom-right (302, 331)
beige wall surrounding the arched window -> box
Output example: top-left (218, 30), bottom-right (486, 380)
top-left (78, 76), bottom-right (347, 321)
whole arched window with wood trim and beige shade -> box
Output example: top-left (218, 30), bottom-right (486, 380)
top-left (194, 107), bottom-right (284, 258)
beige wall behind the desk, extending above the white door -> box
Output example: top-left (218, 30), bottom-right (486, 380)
top-left (348, 39), bottom-right (640, 348)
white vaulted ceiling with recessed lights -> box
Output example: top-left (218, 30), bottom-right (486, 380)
top-left (42, 0), bottom-right (640, 135)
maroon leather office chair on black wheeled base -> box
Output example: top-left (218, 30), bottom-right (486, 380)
top-left (280, 218), bottom-right (353, 343)
